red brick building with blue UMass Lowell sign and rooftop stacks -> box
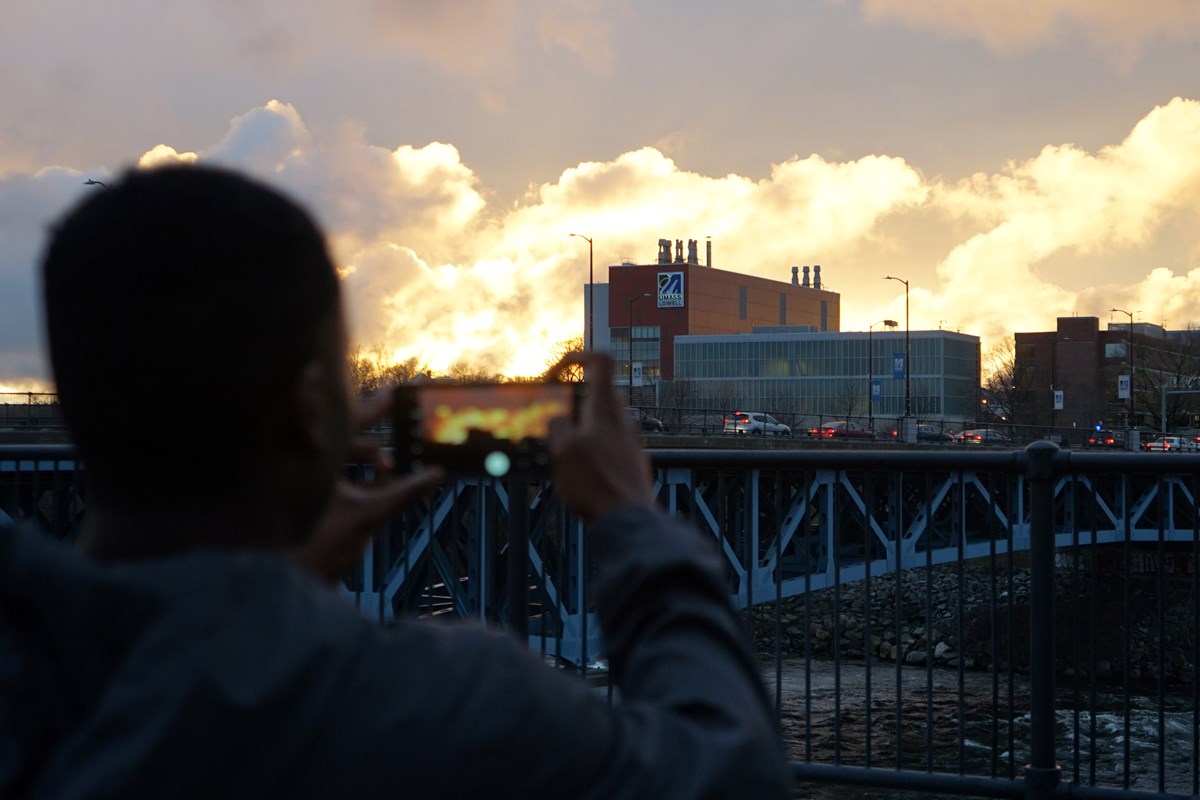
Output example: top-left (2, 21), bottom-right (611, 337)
top-left (595, 239), bottom-right (841, 401)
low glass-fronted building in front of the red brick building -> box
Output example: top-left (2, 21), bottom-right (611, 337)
top-left (672, 330), bottom-right (979, 422)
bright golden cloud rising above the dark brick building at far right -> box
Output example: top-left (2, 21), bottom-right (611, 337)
top-left (907, 98), bottom-right (1200, 338)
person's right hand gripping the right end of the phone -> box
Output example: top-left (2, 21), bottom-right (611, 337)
top-left (548, 353), bottom-right (654, 521)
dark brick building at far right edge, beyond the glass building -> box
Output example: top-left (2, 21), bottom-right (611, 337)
top-left (1010, 317), bottom-right (1200, 432)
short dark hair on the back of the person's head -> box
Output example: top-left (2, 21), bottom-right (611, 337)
top-left (42, 166), bottom-right (340, 496)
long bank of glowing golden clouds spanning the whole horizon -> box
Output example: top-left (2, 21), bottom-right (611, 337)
top-left (0, 98), bottom-right (1200, 391)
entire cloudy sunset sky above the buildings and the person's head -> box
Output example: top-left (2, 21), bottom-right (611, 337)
top-left (0, 0), bottom-right (1200, 391)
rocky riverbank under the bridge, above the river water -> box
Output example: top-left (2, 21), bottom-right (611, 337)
top-left (754, 563), bottom-right (1196, 687)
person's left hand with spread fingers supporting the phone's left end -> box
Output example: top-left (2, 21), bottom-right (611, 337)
top-left (293, 389), bottom-right (444, 583)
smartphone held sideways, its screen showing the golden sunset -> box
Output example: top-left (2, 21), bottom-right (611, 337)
top-left (392, 381), bottom-right (584, 477)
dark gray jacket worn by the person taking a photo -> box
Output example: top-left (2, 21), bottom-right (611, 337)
top-left (0, 509), bottom-right (791, 800)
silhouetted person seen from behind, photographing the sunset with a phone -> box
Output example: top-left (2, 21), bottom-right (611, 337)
top-left (0, 167), bottom-right (790, 799)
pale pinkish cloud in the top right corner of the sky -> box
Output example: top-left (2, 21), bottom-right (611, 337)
top-left (863, 0), bottom-right (1200, 65)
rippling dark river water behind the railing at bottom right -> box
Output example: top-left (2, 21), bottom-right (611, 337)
top-left (767, 658), bottom-right (1196, 800)
